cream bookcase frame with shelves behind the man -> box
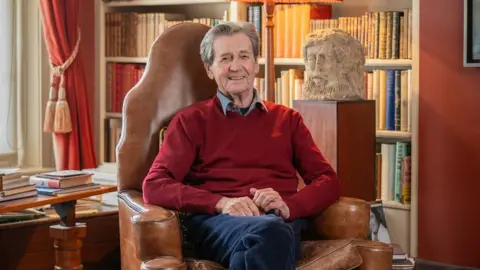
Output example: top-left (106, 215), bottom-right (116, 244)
top-left (95, 0), bottom-right (419, 256)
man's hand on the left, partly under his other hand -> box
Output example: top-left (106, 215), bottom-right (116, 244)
top-left (215, 197), bottom-right (260, 216)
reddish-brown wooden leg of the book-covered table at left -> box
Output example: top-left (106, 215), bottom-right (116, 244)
top-left (50, 201), bottom-right (87, 270)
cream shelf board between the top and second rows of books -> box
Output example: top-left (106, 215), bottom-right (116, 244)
top-left (105, 57), bottom-right (412, 68)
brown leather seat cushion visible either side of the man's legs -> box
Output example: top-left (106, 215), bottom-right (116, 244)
top-left (185, 239), bottom-right (362, 270)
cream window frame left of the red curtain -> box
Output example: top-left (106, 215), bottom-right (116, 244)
top-left (0, 0), bottom-right (55, 168)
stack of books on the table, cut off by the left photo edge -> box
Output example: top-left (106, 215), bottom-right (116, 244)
top-left (0, 168), bottom-right (37, 202)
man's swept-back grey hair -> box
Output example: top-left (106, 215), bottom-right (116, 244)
top-left (200, 21), bottom-right (260, 66)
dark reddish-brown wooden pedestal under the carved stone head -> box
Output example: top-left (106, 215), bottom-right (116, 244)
top-left (293, 100), bottom-right (376, 201)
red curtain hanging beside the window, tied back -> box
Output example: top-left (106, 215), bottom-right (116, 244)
top-left (39, 0), bottom-right (97, 170)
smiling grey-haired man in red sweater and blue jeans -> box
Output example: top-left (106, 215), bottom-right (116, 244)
top-left (143, 22), bottom-right (340, 270)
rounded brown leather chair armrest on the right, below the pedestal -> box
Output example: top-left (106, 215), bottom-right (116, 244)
top-left (314, 197), bottom-right (370, 239)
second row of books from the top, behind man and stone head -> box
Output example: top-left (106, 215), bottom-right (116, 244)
top-left (106, 63), bottom-right (412, 132)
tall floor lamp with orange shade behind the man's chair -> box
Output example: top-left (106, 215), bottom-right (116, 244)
top-left (230, 0), bottom-right (343, 102)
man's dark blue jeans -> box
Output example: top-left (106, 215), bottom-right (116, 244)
top-left (183, 214), bottom-right (307, 270)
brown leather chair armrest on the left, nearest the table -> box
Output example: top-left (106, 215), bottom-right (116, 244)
top-left (118, 190), bottom-right (182, 261)
